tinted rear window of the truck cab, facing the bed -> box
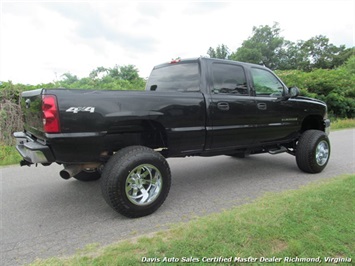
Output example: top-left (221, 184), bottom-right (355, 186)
top-left (146, 63), bottom-right (200, 92)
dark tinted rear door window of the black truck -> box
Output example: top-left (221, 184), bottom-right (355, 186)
top-left (212, 63), bottom-right (249, 95)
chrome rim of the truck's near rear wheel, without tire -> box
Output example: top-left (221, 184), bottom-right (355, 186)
top-left (125, 164), bottom-right (163, 206)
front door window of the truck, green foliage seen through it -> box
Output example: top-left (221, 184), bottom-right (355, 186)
top-left (251, 68), bottom-right (284, 97)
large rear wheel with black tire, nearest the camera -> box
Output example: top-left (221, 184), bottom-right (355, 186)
top-left (101, 146), bottom-right (171, 218)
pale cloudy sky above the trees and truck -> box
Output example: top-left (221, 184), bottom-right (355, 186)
top-left (0, 0), bottom-right (355, 85)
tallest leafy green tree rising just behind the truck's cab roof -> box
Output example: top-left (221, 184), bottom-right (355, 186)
top-left (230, 22), bottom-right (284, 69)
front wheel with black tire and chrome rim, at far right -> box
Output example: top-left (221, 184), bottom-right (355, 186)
top-left (296, 130), bottom-right (330, 174)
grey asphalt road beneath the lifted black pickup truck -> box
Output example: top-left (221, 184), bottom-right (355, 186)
top-left (0, 129), bottom-right (355, 265)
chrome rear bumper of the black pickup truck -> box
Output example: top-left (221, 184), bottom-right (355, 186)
top-left (14, 132), bottom-right (55, 163)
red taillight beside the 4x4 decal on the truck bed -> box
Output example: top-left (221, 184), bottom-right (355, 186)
top-left (42, 95), bottom-right (60, 133)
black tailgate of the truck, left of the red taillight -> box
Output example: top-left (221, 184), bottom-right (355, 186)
top-left (21, 89), bottom-right (44, 139)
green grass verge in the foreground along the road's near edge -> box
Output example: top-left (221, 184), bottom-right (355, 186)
top-left (32, 175), bottom-right (355, 265)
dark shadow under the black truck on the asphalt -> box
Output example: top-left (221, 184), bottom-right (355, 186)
top-left (37, 155), bottom-right (302, 221)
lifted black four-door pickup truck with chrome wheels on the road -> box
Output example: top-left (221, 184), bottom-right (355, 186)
top-left (14, 58), bottom-right (330, 217)
